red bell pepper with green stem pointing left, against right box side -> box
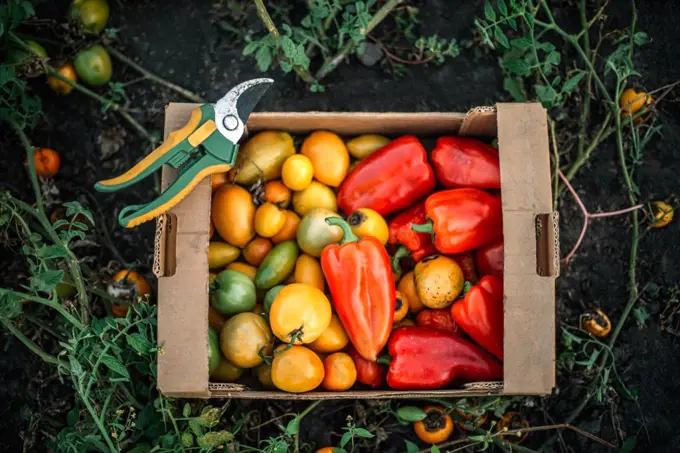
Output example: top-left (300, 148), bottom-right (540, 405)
top-left (411, 188), bottom-right (503, 255)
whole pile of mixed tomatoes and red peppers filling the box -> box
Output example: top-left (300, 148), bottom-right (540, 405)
top-left (202, 131), bottom-right (503, 392)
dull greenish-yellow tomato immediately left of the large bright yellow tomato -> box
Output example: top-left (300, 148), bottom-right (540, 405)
top-left (220, 312), bottom-right (272, 368)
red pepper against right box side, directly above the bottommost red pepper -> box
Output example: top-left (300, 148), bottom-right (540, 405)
top-left (451, 275), bottom-right (503, 360)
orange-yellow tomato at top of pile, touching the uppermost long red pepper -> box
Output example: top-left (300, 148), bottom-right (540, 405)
top-left (300, 131), bottom-right (349, 187)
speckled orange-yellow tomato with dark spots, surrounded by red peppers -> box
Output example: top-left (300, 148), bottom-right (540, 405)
top-left (414, 255), bottom-right (465, 308)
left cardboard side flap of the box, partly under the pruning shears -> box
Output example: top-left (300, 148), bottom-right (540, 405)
top-left (154, 104), bottom-right (211, 398)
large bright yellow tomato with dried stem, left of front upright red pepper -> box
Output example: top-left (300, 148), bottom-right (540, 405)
top-left (269, 283), bottom-right (331, 344)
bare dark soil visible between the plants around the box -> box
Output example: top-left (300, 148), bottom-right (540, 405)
top-left (0, 0), bottom-right (680, 453)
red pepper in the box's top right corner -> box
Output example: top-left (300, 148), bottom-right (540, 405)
top-left (430, 137), bottom-right (501, 189)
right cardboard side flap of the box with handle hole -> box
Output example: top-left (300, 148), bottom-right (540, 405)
top-left (496, 104), bottom-right (557, 394)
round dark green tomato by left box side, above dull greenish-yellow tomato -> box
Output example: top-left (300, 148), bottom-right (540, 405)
top-left (210, 270), bottom-right (257, 316)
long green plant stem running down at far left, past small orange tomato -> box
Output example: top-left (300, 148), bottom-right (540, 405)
top-left (11, 122), bottom-right (90, 325)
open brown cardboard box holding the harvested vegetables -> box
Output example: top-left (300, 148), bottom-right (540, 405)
top-left (154, 103), bottom-right (559, 399)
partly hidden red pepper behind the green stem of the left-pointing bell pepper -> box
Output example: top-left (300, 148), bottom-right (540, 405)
top-left (388, 202), bottom-right (437, 263)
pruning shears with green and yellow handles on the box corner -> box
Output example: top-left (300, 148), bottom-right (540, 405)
top-left (94, 78), bottom-right (274, 228)
